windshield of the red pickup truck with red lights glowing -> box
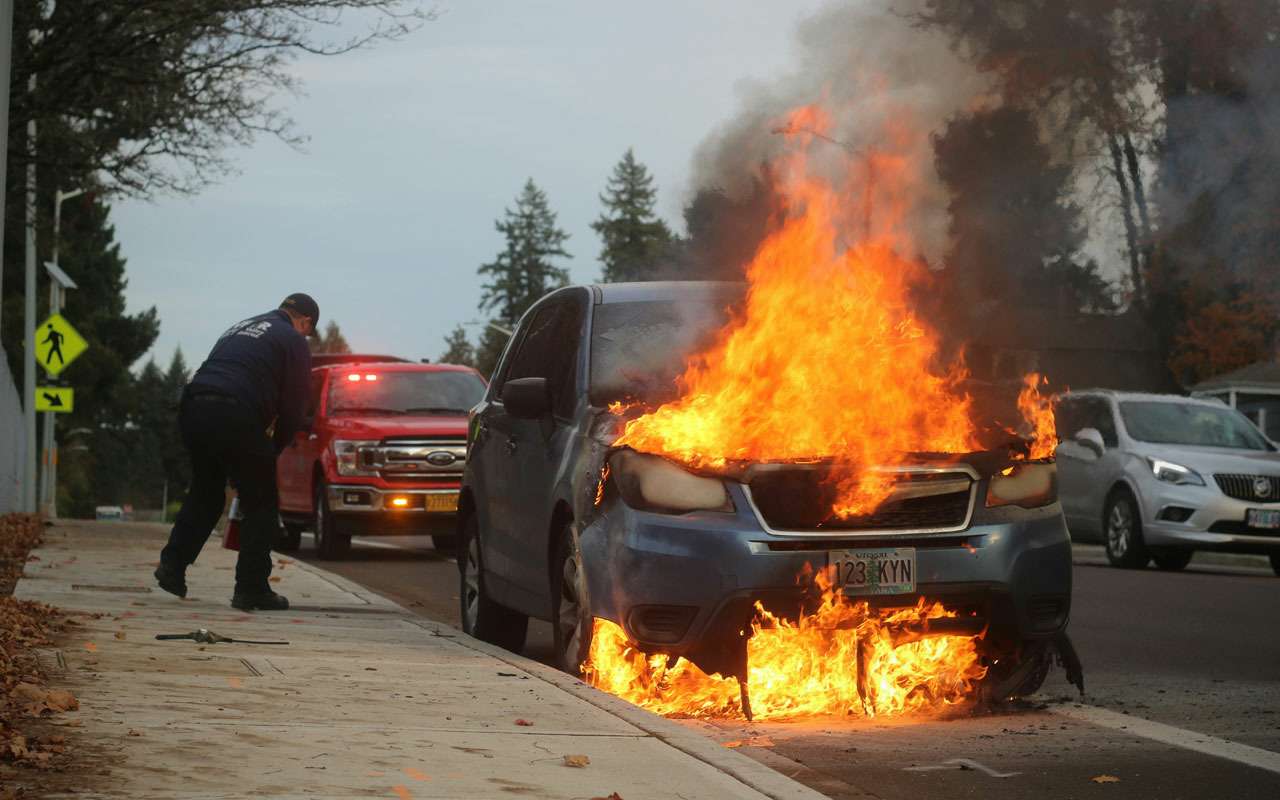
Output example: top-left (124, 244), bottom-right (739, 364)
top-left (328, 369), bottom-right (484, 416)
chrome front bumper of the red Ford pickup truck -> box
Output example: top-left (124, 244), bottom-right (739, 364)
top-left (325, 484), bottom-right (458, 535)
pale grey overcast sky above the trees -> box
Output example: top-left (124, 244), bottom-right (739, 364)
top-left (113, 0), bottom-right (823, 366)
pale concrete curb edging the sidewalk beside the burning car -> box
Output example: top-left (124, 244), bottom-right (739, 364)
top-left (284, 553), bottom-right (826, 800)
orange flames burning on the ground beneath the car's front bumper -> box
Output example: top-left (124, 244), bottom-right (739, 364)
top-left (582, 573), bottom-right (987, 719)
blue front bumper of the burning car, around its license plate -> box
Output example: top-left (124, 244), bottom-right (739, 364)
top-left (581, 498), bottom-right (1071, 654)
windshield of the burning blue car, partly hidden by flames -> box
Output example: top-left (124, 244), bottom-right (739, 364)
top-left (590, 287), bottom-right (741, 407)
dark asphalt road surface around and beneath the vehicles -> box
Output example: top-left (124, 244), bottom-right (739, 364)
top-left (297, 536), bottom-right (1280, 800)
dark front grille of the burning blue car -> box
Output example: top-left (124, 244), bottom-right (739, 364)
top-left (746, 468), bottom-right (974, 532)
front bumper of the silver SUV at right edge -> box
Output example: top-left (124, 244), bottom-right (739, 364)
top-left (1139, 479), bottom-right (1280, 553)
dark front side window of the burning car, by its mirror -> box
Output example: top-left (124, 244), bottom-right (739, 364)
top-left (503, 301), bottom-right (582, 419)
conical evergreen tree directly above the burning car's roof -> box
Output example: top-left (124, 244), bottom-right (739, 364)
top-left (591, 148), bottom-right (672, 283)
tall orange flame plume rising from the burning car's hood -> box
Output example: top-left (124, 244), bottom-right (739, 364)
top-left (616, 106), bottom-right (979, 517)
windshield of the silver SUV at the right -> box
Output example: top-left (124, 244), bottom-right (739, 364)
top-left (1120, 401), bottom-right (1272, 451)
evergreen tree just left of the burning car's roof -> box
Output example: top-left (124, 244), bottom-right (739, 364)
top-left (477, 178), bottom-right (568, 328)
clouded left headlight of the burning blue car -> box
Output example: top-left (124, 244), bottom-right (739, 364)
top-left (609, 451), bottom-right (733, 513)
